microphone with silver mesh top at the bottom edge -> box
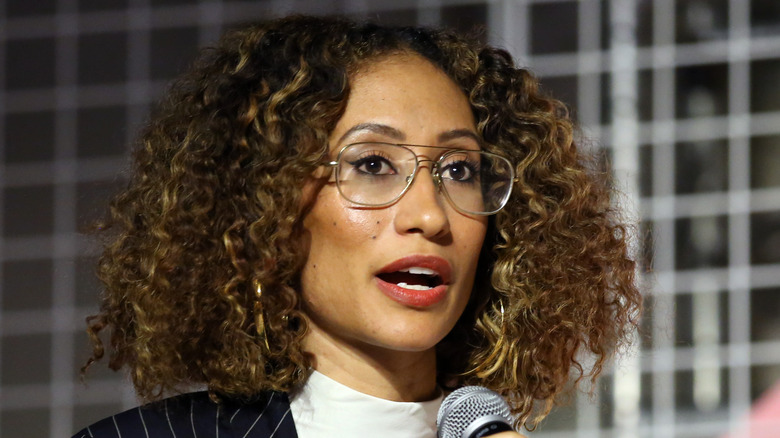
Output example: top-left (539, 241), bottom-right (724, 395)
top-left (436, 386), bottom-right (514, 438)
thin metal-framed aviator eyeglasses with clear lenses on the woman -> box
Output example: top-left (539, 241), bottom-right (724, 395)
top-left (326, 142), bottom-right (515, 215)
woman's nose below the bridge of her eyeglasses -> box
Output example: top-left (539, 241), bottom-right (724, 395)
top-left (394, 160), bottom-right (450, 239)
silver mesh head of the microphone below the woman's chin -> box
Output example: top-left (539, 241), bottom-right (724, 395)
top-left (436, 386), bottom-right (513, 438)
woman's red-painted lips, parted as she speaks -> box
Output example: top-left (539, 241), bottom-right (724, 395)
top-left (374, 255), bottom-right (452, 307)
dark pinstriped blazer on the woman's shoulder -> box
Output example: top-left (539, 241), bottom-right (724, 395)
top-left (73, 392), bottom-right (298, 438)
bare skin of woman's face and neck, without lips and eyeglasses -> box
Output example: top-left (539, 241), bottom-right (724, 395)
top-left (301, 55), bottom-right (487, 401)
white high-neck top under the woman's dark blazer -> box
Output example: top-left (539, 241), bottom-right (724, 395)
top-left (290, 371), bottom-right (444, 438)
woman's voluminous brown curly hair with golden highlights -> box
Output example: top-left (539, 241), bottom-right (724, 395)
top-left (85, 16), bottom-right (640, 428)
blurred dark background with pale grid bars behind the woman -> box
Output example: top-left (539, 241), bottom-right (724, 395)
top-left (0, 0), bottom-right (780, 437)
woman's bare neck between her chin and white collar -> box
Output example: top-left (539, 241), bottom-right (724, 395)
top-left (303, 324), bottom-right (438, 402)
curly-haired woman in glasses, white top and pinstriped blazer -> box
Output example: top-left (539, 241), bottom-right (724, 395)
top-left (76, 17), bottom-right (640, 437)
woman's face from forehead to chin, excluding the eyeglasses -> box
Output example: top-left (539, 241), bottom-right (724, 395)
top-left (302, 55), bottom-right (487, 355)
